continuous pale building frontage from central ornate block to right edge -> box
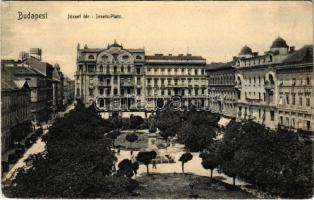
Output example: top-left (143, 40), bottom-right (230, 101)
top-left (75, 37), bottom-right (314, 134)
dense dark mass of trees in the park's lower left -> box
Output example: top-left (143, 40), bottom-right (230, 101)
top-left (2, 102), bottom-right (138, 198)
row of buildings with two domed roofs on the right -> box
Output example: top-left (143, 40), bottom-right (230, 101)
top-left (207, 37), bottom-right (314, 132)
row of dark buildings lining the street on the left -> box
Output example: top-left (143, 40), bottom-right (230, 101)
top-left (1, 48), bottom-right (74, 153)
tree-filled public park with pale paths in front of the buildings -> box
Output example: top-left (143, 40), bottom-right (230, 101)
top-left (2, 103), bottom-right (313, 199)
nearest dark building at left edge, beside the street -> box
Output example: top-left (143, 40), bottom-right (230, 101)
top-left (1, 64), bottom-right (31, 153)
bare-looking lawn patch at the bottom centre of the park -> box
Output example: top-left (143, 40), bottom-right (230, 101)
top-left (127, 173), bottom-right (256, 199)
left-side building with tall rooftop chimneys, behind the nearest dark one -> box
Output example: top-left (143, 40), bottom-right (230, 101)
top-left (2, 48), bottom-right (53, 123)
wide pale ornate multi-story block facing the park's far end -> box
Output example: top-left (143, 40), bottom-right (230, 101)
top-left (75, 42), bottom-right (207, 110)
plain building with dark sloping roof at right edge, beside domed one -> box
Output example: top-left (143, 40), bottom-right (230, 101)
top-left (276, 45), bottom-right (314, 132)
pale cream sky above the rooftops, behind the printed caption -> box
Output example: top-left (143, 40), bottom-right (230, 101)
top-left (1, 1), bottom-right (313, 78)
